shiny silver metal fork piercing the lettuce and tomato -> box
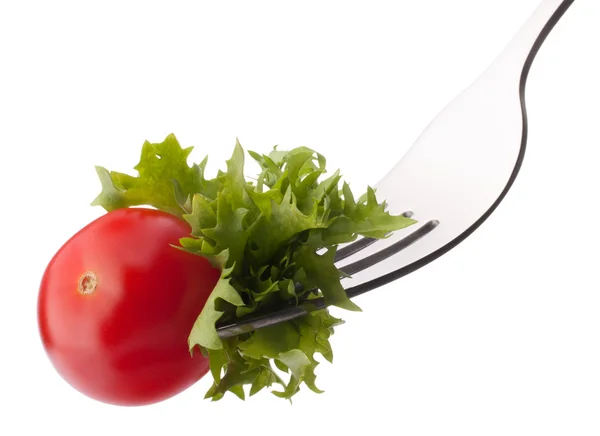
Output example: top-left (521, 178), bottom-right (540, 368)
top-left (217, 0), bottom-right (575, 338)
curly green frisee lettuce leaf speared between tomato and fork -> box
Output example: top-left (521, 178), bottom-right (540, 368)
top-left (92, 134), bottom-right (415, 401)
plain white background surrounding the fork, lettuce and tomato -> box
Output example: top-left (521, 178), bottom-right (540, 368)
top-left (0, 0), bottom-right (600, 436)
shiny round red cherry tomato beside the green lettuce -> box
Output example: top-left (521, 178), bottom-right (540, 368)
top-left (38, 208), bottom-right (220, 406)
